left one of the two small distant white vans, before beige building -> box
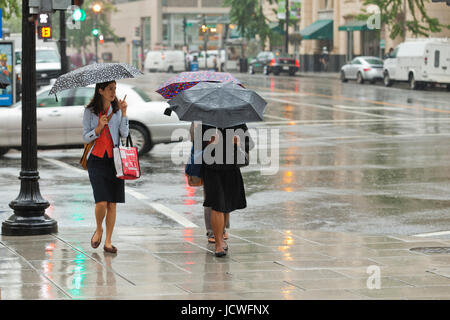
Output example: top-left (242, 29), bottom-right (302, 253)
top-left (144, 50), bottom-right (186, 72)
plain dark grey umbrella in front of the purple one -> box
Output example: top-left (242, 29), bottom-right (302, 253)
top-left (168, 82), bottom-right (267, 128)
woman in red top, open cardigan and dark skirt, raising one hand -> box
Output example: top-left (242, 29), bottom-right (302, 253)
top-left (83, 81), bottom-right (129, 253)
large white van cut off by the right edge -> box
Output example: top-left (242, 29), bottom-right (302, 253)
top-left (383, 38), bottom-right (450, 90)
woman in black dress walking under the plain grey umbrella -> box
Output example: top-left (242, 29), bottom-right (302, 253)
top-left (202, 124), bottom-right (253, 257)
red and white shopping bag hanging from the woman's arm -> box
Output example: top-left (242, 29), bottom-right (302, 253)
top-left (113, 135), bottom-right (141, 180)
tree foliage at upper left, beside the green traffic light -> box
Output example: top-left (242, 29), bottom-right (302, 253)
top-left (67, 0), bottom-right (118, 53)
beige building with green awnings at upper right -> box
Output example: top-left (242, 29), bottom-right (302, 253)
top-left (298, 0), bottom-right (450, 72)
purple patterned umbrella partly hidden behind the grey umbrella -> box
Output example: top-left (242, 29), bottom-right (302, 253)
top-left (156, 71), bottom-right (242, 99)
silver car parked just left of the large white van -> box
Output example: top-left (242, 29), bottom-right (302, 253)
top-left (341, 57), bottom-right (383, 84)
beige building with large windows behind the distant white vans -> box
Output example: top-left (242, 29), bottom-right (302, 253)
top-left (92, 0), bottom-right (229, 67)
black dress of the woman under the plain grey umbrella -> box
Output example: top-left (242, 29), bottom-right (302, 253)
top-left (202, 124), bottom-right (253, 213)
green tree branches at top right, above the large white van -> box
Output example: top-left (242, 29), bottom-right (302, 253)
top-left (357, 0), bottom-right (450, 39)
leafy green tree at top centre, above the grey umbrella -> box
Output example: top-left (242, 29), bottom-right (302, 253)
top-left (224, 0), bottom-right (273, 44)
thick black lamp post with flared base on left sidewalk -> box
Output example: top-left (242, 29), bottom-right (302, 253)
top-left (2, 0), bottom-right (58, 236)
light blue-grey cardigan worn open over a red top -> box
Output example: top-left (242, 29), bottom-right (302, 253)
top-left (83, 108), bottom-right (129, 159)
